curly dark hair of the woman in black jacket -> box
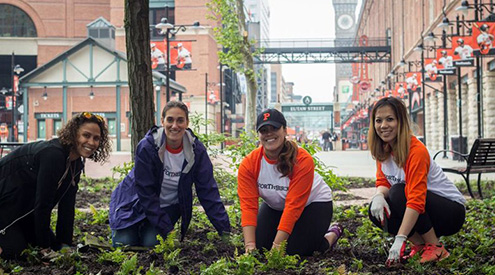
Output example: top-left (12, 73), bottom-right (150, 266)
top-left (57, 112), bottom-right (111, 163)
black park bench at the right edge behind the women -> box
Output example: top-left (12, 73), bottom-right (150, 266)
top-left (433, 138), bottom-right (495, 198)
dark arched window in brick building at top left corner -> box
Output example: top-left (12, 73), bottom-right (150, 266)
top-left (0, 4), bottom-right (37, 37)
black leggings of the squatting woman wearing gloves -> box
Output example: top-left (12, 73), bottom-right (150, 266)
top-left (369, 184), bottom-right (466, 237)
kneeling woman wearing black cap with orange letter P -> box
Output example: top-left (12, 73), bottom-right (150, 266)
top-left (238, 109), bottom-right (342, 256)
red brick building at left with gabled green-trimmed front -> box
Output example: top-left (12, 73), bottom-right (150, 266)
top-left (0, 0), bottom-right (240, 150)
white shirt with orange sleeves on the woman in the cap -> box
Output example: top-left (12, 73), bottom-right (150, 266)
top-left (237, 147), bottom-right (332, 234)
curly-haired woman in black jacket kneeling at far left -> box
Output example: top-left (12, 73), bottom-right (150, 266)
top-left (0, 112), bottom-right (110, 259)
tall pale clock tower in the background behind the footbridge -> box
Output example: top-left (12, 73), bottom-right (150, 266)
top-left (333, 0), bottom-right (359, 133)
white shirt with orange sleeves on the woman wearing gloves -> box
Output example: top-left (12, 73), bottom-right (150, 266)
top-left (376, 136), bottom-right (466, 214)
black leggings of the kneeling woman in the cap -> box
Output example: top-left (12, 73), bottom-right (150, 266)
top-left (256, 201), bottom-right (333, 256)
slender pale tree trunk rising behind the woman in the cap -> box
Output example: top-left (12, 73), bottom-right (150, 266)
top-left (236, 0), bottom-right (257, 133)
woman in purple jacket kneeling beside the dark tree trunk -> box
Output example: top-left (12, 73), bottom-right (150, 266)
top-left (109, 101), bottom-right (230, 247)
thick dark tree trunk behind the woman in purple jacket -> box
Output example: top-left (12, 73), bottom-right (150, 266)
top-left (124, 0), bottom-right (155, 158)
